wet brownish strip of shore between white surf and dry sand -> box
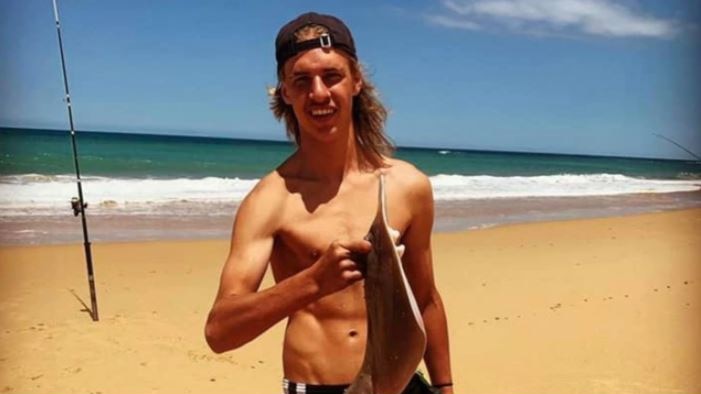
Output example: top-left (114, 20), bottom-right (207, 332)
top-left (0, 191), bottom-right (701, 247)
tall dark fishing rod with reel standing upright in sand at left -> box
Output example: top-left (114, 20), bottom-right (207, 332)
top-left (52, 0), bottom-right (100, 321)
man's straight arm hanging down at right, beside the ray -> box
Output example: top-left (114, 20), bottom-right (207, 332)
top-left (401, 173), bottom-right (453, 394)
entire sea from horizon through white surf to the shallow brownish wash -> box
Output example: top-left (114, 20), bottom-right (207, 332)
top-left (0, 128), bottom-right (701, 244)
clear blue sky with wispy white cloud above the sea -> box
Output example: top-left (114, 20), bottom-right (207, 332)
top-left (0, 0), bottom-right (701, 159)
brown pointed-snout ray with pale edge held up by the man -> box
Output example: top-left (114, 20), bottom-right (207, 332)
top-left (346, 175), bottom-right (426, 394)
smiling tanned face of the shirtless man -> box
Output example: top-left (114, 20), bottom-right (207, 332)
top-left (281, 48), bottom-right (362, 141)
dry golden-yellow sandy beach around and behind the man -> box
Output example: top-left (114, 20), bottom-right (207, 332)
top-left (0, 209), bottom-right (701, 394)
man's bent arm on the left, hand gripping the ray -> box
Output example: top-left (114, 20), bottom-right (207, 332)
top-left (205, 180), bottom-right (370, 353)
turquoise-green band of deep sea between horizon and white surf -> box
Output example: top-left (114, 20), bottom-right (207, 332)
top-left (0, 128), bottom-right (701, 180)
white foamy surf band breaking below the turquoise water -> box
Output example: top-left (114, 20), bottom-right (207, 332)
top-left (0, 174), bottom-right (701, 217)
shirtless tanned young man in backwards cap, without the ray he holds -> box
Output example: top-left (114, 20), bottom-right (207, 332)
top-left (205, 13), bottom-right (453, 394)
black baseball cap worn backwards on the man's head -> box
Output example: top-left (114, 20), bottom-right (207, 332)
top-left (275, 12), bottom-right (358, 70)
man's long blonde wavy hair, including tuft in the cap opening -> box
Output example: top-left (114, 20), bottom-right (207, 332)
top-left (270, 25), bottom-right (394, 168)
